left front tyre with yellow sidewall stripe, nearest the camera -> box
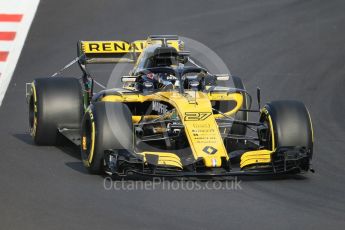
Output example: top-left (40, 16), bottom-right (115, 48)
top-left (81, 102), bottom-right (133, 174)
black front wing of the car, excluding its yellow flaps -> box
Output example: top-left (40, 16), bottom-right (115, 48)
top-left (104, 147), bottom-right (313, 177)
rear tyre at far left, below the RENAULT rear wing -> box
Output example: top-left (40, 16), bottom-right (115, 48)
top-left (29, 77), bottom-right (83, 145)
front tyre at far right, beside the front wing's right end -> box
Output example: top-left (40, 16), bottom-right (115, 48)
top-left (260, 101), bottom-right (313, 157)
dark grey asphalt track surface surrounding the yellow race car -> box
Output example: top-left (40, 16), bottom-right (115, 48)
top-left (0, 0), bottom-right (345, 229)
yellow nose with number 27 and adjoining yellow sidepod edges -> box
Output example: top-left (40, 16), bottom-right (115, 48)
top-left (100, 91), bottom-right (243, 167)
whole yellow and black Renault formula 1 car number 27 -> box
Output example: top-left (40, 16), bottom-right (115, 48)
top-left (27, 35), bottom-right (314, 177)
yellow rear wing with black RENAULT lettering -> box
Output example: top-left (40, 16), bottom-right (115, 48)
top-left (78, 35), bottom-right (184, 64)
